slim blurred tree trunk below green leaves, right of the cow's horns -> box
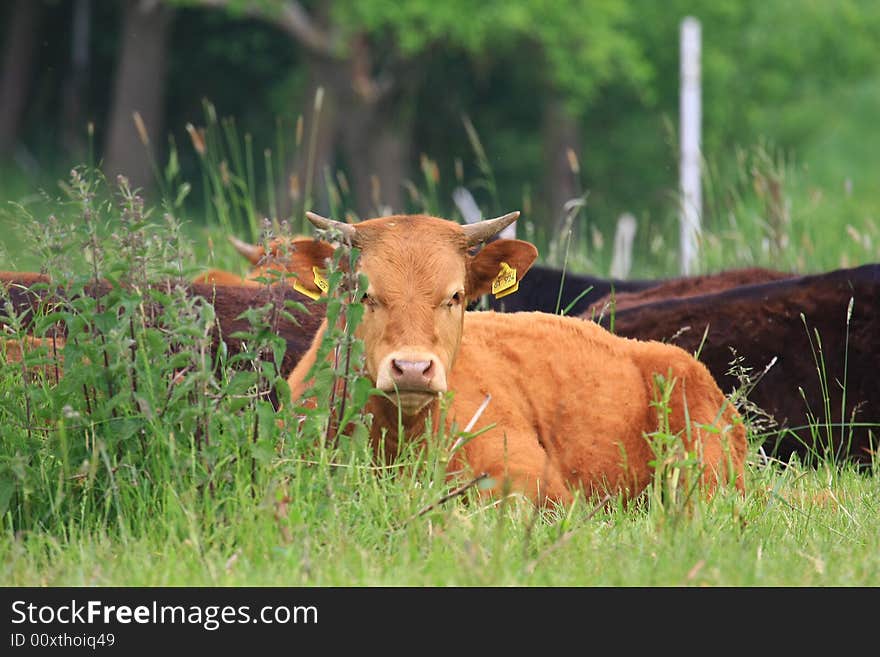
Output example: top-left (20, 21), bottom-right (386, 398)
top-left (543, 93), bottom-right (583, 230)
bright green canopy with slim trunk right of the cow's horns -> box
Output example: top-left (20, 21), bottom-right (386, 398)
top-left (340, 0), bottom-right (652, 223)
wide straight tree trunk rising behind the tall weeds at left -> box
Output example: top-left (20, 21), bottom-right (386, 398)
top-left (104, 0), bottom-right (173, 194)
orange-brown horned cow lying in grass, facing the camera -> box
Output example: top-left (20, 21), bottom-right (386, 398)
top-left (288, 212), bottom-right (747, 503)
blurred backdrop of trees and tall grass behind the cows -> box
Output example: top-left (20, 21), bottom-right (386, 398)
top-left (0, 0), bottom-right (880, 277)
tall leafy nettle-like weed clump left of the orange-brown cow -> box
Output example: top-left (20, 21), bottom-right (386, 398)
top-left (0, 170), bottom-right (296, 533)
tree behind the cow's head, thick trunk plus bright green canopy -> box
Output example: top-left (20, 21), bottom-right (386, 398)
top-left (178, 0), bottom-right (650, 223)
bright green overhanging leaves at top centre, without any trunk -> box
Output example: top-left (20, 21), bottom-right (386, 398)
top-left (333, 0), bottom-right (651, 106)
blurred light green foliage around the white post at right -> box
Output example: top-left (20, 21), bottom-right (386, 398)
top-left (560, 0), bottom-right (880, 275)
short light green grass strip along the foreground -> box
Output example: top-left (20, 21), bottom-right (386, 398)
top-left (0, 464), bottom-right (880, 586)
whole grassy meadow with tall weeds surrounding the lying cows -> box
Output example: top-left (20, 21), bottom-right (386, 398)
top-left (0, 106), bottom-right (880, 586)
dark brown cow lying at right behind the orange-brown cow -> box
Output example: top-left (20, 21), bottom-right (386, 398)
top-left (601, 264), bottom-right (880, 464)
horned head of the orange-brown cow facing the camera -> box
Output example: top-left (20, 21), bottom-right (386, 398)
top-left (300, 212), bottom-right (538, 416)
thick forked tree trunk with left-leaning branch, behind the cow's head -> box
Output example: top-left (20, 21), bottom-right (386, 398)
top-left (175, 0), bottom-right (409, 215)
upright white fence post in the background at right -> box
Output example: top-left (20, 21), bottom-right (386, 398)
top-left (679, 16), bottom-right (703, 276)
